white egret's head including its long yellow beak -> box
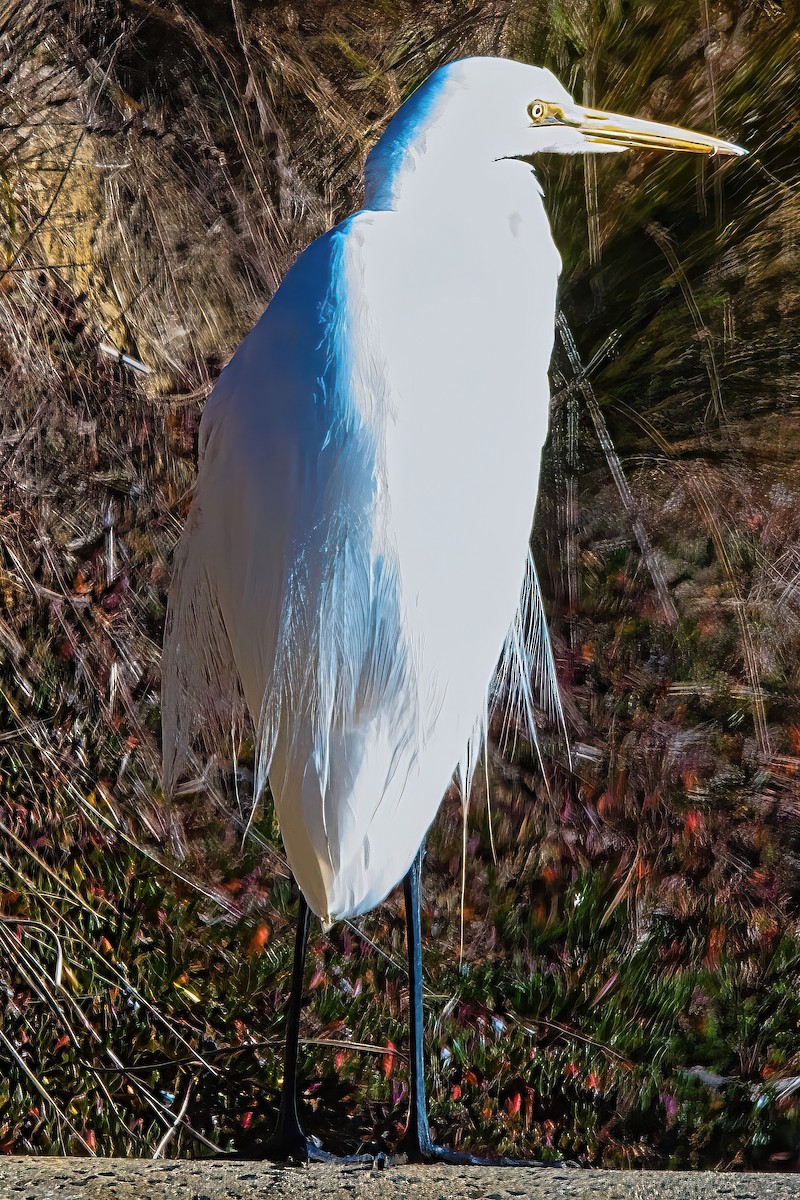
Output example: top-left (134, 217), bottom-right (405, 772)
top-left (366, 58), bottom-right (746, 206)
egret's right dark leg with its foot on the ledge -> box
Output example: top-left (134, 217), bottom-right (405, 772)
top-left (399, 844), bottom-right (542, 1166)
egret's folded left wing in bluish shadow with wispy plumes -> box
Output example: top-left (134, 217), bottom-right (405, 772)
top-left (163, 214), bottom-right (413, 816)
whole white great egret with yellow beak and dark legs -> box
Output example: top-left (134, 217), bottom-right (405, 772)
top-left (163, 58), bottom-right (745, 1162)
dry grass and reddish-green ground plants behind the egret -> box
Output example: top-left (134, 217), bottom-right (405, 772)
top-left (0, 0), bottom-right (800, 1170)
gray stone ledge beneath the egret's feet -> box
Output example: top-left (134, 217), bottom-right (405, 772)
top-left (0, 1158), bottom-right (800, 1200)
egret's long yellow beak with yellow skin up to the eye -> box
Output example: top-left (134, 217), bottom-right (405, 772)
top-left (528, 100), bottom-right (747, 155)
